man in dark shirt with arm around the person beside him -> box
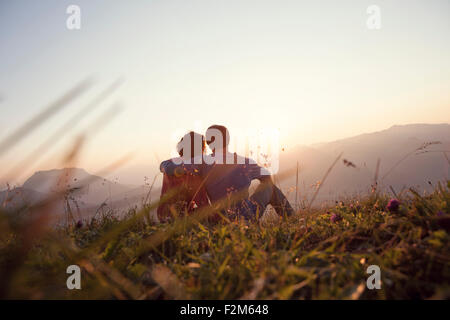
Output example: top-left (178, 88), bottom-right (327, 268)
top-left (161, 125), bottom-right (294, 219)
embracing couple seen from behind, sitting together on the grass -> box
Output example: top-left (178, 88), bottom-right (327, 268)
top-left (157, 125), bottom-right (294, 222)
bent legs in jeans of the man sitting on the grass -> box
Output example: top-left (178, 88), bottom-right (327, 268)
top-left (250, 179), bottom-right (294, 216)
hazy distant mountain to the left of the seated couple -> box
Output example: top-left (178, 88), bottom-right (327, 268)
top-left (0, 168), bottom-right (159, 224)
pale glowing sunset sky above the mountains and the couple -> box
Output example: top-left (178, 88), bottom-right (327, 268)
top-left (0, 0), bottom-right (450, 184)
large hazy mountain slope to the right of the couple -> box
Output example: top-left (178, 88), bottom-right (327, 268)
top-left (280, 124), bottom-right (450, 206)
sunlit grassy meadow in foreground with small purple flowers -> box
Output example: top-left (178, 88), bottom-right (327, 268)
top-left (0, 182), bottom-right (450, 299)
